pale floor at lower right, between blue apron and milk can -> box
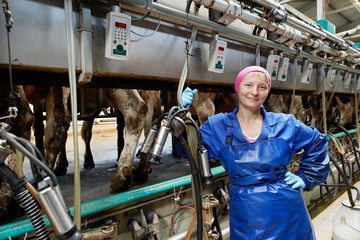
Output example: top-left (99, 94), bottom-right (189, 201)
top-left (312, 181), bottom-right (360, 240)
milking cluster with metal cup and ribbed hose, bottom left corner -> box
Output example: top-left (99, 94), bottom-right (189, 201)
top-left (0, 123), bottom-right (82, 240)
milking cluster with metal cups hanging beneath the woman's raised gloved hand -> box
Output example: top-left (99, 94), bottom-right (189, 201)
top-left (137, 106), bottom-right (220, 239)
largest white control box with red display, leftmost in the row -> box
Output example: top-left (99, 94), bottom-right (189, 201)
top-left (105, 12), bottom-right (131, 60)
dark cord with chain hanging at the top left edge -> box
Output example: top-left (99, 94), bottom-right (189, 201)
top-left (2, 0), bottom-right (19, 118)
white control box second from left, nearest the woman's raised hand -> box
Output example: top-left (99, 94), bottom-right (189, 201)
top-left (208, 40), bottom-right (227, 73)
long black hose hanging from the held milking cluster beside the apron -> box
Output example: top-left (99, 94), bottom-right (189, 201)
top-left (178, 136), bottom-right (203, 240)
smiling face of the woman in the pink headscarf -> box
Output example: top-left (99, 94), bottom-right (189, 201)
top-left (238, 72), bottom-right (269, 111)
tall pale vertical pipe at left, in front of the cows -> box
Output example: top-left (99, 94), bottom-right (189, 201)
top-left (64, 0), bottom-right (81, 230)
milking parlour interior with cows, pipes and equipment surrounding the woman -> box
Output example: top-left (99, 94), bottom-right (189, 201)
top-left (0, 0), bottom-right (360, 240)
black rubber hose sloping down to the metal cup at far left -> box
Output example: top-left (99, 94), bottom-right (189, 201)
top-left (0, 130), bottom-right (58, 187)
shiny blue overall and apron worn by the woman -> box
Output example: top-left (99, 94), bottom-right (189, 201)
top-left (201, 108), bottom-right (329, 240)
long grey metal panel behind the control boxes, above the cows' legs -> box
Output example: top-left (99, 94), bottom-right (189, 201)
top-left (0, 0), bottom-right (355, 92)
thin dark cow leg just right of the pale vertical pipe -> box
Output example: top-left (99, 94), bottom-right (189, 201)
top-left (81, 119), bottom-right (95, 169)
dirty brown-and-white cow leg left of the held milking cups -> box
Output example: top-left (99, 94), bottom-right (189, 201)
top-left (107, 89), bottom-right (147, 192)
